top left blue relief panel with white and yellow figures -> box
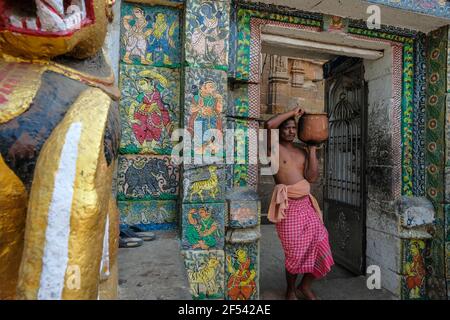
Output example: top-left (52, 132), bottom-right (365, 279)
top-left (120, 2), bottom-right (181, 67)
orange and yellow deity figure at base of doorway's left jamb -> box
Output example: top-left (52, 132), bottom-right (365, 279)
top-left (227, 249), bottom-right (256, 300)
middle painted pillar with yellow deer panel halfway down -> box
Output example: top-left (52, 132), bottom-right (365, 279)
top-left (181, 0), bottom-right (230, 299)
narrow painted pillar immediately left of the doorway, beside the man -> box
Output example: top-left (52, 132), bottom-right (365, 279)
top-left (225, 1), bottom-right (261, 300)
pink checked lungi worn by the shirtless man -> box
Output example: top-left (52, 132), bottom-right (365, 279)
top-left (276, 196), bottom-right (334, 278)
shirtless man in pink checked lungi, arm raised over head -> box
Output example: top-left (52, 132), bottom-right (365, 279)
top-left (266, 107), bottom-right (334, 300)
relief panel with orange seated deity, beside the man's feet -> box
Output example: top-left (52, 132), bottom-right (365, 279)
top-left (225, 242), bottom-right (259, 300)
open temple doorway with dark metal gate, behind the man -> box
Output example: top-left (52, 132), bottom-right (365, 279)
top-left (258, 20), bottom-right (398, 299)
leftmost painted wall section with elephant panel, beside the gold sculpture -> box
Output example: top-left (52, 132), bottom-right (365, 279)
top-left (117, 1), bottom-right (182, 230)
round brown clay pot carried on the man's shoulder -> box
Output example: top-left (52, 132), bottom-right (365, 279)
top-left (297, 113), bottom-right (328, 144)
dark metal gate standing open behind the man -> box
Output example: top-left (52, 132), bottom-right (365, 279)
top-left (324, 57), bottom-right (367, 274)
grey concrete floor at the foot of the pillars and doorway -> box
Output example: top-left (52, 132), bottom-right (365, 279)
top-left (119, 225), bottom-right (394, 300)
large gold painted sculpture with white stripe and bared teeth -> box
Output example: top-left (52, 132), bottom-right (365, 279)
top-left (0, 0), bottom-right (119, 299)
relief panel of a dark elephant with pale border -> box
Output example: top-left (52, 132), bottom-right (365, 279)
top-left (117, 155), bottom-right (179, 200)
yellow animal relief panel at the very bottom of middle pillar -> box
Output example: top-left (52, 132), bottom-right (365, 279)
top-left (183, 250), bottom-right (225, 300)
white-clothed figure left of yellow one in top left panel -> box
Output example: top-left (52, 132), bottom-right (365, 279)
top-left (123, 7), bottom-right (153, 64)
